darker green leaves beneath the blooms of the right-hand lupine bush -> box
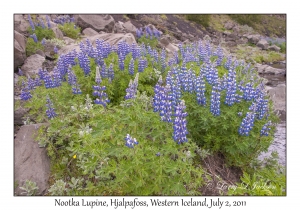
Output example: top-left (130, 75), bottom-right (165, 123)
top-left (183, 67), bottom-right (279, 168)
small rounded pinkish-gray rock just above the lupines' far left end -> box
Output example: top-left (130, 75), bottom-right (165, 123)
top-left (21, 54), bottom-right (45, 76)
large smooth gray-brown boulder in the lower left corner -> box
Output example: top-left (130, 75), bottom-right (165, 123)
top-left (14, 124), bottom-right (50, 195)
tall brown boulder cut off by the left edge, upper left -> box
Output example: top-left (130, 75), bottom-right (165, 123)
top-left (14, 31), bottom-right (26, 70)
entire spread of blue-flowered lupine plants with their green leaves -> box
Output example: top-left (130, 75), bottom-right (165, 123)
top-left (15, 14), bottom-right (285, 195)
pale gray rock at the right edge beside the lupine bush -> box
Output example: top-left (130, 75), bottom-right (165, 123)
top-left (267, 84), bottom-right (286, 119)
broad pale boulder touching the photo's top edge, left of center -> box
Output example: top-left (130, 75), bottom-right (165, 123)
top-left (74, 15), bottom-right (115, 32)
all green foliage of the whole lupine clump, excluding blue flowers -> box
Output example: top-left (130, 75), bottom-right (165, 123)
top-left (19, 38), bottom-right (284, 195)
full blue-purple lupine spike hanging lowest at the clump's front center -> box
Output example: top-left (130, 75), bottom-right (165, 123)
top-left (173, 100), bottom-right (188, 144)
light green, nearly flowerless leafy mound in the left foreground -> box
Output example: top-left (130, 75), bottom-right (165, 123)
top-left (42, 100), bottom-right (202, 195)
